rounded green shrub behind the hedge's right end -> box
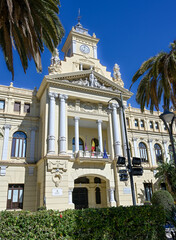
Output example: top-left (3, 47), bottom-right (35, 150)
top-left (151, 190), bottom-right (174, 213)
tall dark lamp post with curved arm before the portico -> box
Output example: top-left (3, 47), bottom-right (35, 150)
top-left (108, 94), bottom-right (136, 206)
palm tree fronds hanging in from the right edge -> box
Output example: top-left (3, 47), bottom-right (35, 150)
top-left (130, 41), bottom-right (176, 112)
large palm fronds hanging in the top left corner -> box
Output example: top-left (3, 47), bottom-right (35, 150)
top-left (0, 0), bottom-right (64, 77)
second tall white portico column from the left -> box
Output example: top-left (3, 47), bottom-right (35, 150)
top-left (59, 94), bottom-right (68, 154)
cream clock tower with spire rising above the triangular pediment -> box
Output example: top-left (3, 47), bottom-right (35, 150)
top-left (49, 17), bottom-right (112, 80)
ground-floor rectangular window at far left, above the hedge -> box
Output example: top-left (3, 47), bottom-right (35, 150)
top-left (7, 184), bottom-right (24, 209)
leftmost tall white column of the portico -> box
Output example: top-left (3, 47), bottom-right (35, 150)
top-left (48, 92), bottom-right (58, 154)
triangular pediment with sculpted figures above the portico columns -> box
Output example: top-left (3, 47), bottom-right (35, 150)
top-left (47, 70), bottom-right (132, 97)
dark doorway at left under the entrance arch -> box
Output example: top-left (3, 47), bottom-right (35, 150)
top-left (73, 187), bottom-right (88, 209)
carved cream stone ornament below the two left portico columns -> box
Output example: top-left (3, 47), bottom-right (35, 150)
top-left (48, 161), bottom-right (67, 187)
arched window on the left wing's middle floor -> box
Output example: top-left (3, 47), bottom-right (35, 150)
top-left (12, 132), bottom-right (27, 157)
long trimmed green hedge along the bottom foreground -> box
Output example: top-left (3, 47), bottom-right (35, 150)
top-left (0, 206), bottom-right (165, 240)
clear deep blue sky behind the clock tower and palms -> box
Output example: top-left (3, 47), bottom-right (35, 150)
top-left (0, 0), bottom-right (176, 107)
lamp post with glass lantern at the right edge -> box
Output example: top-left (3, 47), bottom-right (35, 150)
top-left (159, 109), bottom-right (176, 166)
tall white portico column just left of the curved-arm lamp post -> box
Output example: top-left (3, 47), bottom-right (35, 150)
top-left (112, 103), bottom-right (121, 157)
